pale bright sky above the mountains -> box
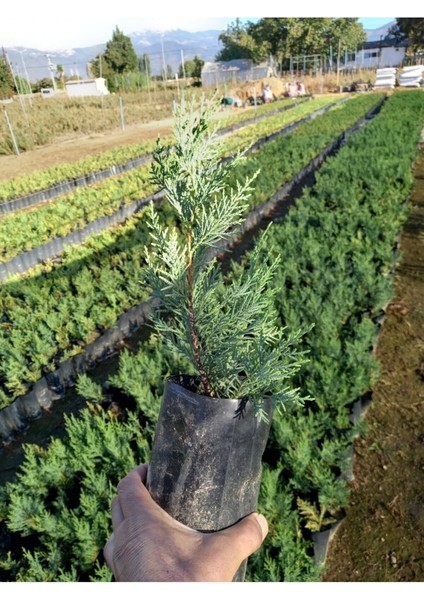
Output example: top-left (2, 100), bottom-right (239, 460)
top-left (0, 0), bottom-right (413, 51)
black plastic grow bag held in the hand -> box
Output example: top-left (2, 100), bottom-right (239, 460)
top-left (147, 376), bottom-right (271, 581)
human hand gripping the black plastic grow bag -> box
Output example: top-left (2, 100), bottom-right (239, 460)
top-left (104, 465), bottom-right (268, 582)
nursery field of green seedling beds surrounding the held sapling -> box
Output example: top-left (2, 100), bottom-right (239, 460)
top-left (0, 90), bottom-right (424, 581)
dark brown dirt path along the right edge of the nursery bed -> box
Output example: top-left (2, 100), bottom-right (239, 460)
top-left (323, 147), bottom-right (424, 582)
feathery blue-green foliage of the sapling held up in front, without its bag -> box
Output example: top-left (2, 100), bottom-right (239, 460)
top-left (146, 98), bottom-right (304, 418)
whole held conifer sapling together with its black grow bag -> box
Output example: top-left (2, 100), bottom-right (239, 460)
top-left (146, 99), bottom-right (305, 581)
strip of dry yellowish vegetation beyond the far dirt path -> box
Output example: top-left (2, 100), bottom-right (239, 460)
top-left (0, 71), bottom-right (374, 155)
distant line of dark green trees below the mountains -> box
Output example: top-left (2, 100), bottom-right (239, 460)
top-left (0, 17), bottom-right (424, 99)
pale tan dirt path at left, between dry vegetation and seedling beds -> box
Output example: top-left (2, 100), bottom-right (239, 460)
top-left (0, 118), bottom-right (172, 181)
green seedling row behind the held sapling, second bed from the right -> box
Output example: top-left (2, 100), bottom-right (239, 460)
top-left (0, 96), bottom-right (380, 408)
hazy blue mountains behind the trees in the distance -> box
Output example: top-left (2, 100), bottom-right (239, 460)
top-left (5, 22), bottom-right (393, 82)
